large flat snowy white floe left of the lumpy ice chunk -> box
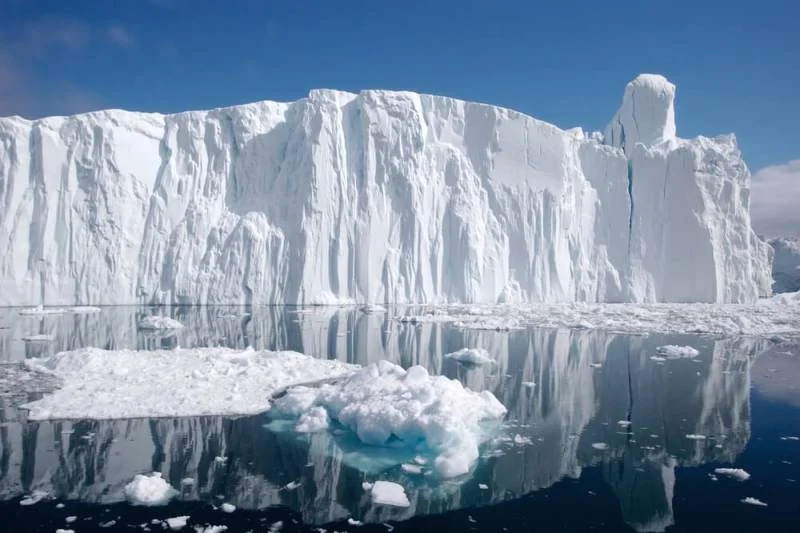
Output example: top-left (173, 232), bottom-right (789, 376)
top-left (25, 348), bottom-right (358, 420)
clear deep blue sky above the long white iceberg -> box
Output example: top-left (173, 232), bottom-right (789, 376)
top-left (0, 0), bottom-right (800, 214)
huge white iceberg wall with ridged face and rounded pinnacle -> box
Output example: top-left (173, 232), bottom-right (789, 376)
top-left (0, 75), bottom-right (772, 305)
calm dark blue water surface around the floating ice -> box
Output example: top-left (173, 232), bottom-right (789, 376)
top-left (0, 308), bottom-right (800, 532)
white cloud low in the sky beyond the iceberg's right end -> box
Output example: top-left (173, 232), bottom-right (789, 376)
top-left (750, 159), bottom-right (800, 237)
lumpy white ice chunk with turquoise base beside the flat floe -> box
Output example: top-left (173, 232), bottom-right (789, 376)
top-left (270, 361), bottom-right (506, 478)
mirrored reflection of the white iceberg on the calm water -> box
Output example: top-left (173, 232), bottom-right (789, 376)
top-left (0, 308), bottom-right (766, 531)
